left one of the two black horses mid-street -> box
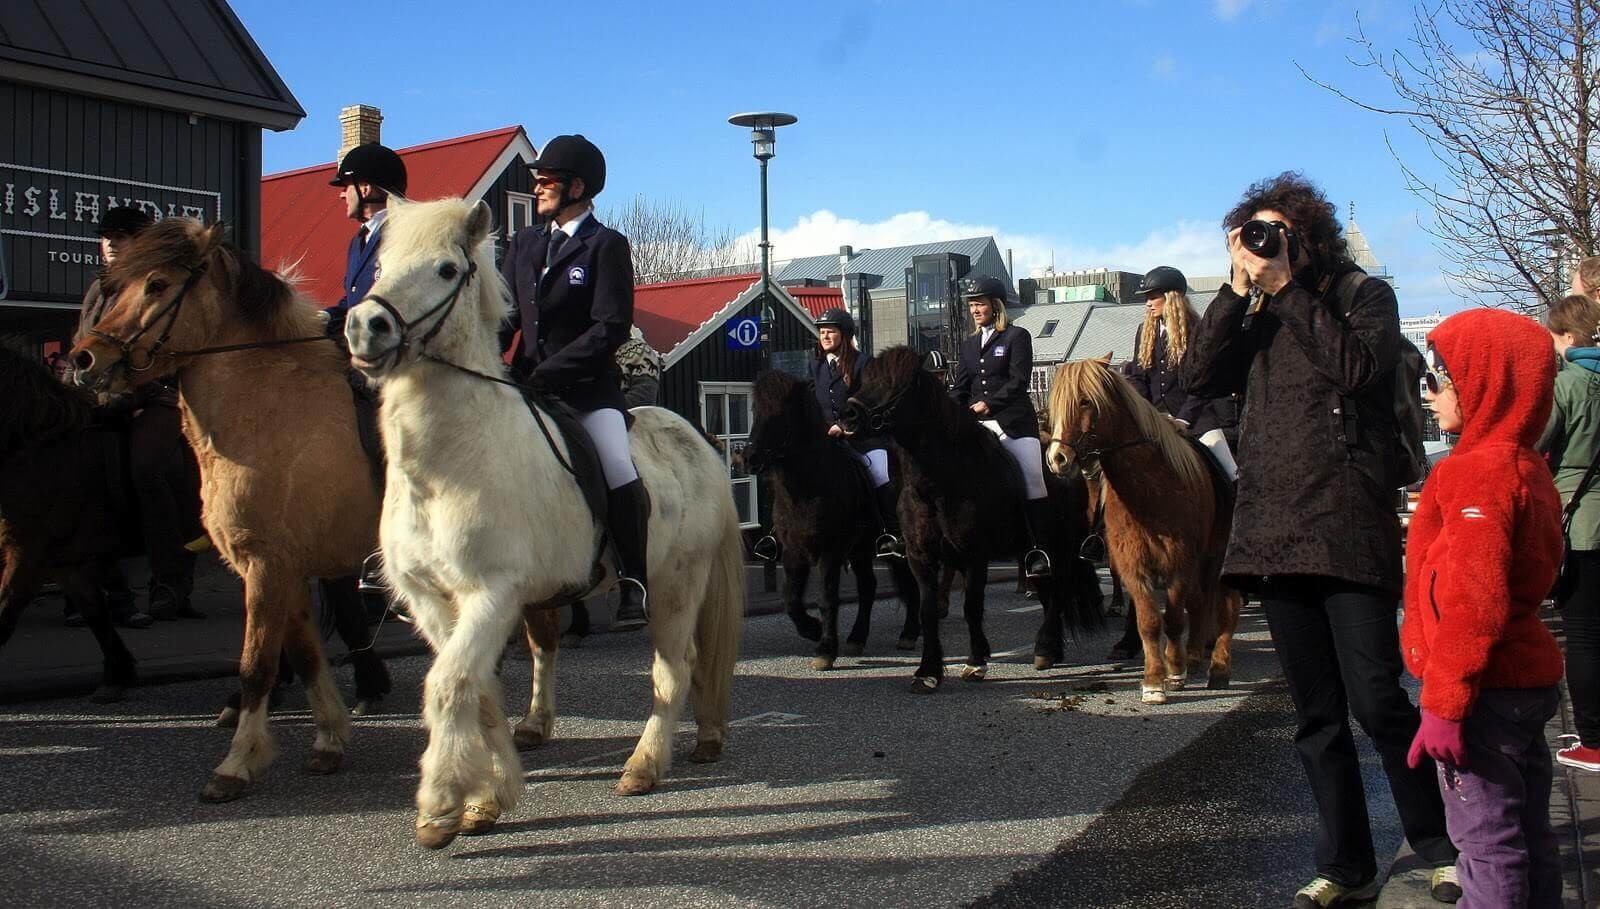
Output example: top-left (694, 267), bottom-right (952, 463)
top-left (741, 370), bottom-right (922, 669)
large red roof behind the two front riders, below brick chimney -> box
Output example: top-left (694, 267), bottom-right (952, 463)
top-left (261, 126), bottom-right (523, 306)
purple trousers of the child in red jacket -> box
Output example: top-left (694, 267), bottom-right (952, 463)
top-left (1438, 685), bottom-right (1562, 909)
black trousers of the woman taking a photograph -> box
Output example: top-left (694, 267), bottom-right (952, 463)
top-left (1261, 578), bottom-right (1456, 887)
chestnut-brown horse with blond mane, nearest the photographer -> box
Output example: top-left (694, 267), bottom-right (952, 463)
top-left (1046, 360), bottom-right (1240, 704)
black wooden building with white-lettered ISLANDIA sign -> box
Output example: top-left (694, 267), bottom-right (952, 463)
top-left (0, 0), bottom-right (306, 354)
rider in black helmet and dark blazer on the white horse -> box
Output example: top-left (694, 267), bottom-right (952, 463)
top-left (501, 136), bottom-right (650, 629)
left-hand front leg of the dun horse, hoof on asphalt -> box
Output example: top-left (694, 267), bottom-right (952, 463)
top-left (200, 562), bottom-right (291, 802)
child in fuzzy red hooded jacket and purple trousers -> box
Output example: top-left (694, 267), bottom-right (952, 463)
top-left (1400, 309), bottom-right (1562, 907)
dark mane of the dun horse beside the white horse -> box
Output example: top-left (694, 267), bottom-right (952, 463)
top-left (102, 218), bottom-right (294, 325)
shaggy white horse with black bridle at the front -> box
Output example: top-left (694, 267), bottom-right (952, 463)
top-left (346, 198), bottom-right (744, 848)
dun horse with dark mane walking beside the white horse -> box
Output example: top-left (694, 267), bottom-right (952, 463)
top-left (72, 218), bottom-right (400, 802)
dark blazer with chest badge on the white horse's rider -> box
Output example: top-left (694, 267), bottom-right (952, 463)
top-left (501, 213), bottom-right (634, 411)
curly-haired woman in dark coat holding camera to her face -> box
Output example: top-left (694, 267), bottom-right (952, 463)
top-left (1182, 173), bottom-right (1459, 907)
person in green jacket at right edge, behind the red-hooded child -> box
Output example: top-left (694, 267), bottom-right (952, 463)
top-left (1529, 288), bottom-right (1600, 771)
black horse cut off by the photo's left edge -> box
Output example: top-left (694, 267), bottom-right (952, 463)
top-left (0, 347), bottom-right (139, 703)
